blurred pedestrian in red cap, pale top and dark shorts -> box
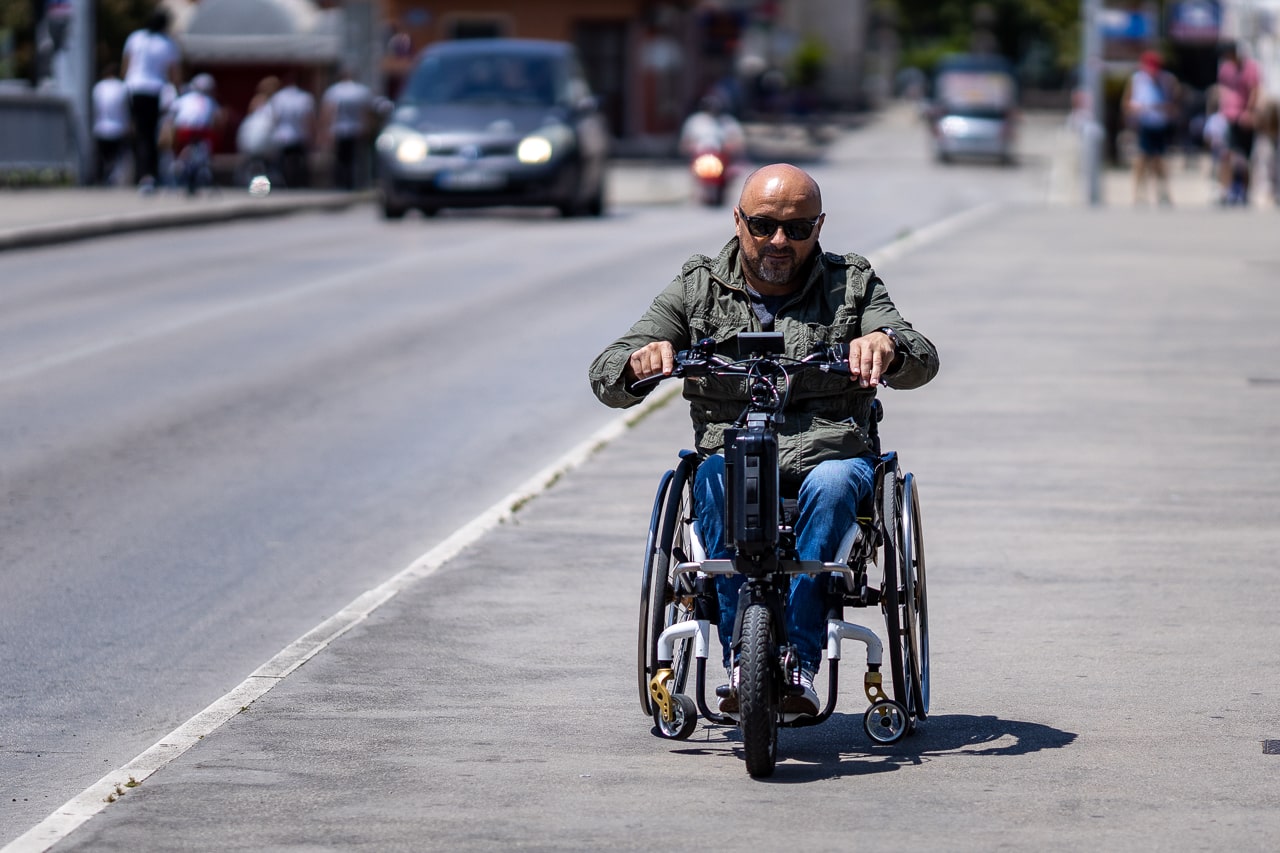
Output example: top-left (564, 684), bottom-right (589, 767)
top-left (1121, 50), bottom-right (1179, 206)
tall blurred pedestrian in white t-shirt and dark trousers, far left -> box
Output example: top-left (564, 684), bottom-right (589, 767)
top-left (120, 9), bottom-right (182, 192)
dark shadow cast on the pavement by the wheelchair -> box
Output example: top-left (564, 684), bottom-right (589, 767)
top-left (671, 713), bottom-right (1076, 784)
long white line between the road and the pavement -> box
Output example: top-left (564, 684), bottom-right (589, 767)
top-left (0, 204), bottom-right (1000, 853)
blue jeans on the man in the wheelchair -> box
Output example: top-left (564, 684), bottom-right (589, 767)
top-left (694, 455), bottom-right (876, 672)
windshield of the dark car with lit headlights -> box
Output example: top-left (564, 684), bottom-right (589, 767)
top-left (402, 54), bottom-right (561, 106)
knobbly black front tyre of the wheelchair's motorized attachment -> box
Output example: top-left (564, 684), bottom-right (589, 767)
top-left (737, 605), bottom-right (778, 779)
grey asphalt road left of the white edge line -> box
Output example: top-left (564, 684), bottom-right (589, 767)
top-left (0, 103), bottom-right (1047, 839)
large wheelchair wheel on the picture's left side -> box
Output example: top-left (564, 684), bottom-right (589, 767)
top-left (636, 457), bottom-right (698, 738)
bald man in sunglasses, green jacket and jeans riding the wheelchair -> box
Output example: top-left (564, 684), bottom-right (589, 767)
top-left (589, 164), bottom-right (938, 715)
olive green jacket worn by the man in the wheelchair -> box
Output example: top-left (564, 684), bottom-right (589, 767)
top-left (589, 237), bottom-right (938, 488)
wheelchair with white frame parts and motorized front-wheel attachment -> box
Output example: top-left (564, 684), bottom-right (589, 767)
top-left (636, 336), bottom-right (929, 777)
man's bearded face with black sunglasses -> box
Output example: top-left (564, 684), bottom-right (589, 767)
top-left (733, 196), bottom-right (823, 287)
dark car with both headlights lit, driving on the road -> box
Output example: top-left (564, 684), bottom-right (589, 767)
top-left (378, 38), bottom-right (608, 219)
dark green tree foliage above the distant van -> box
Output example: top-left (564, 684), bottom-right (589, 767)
top-left (882, 0), bottom-right (1080, 81)
